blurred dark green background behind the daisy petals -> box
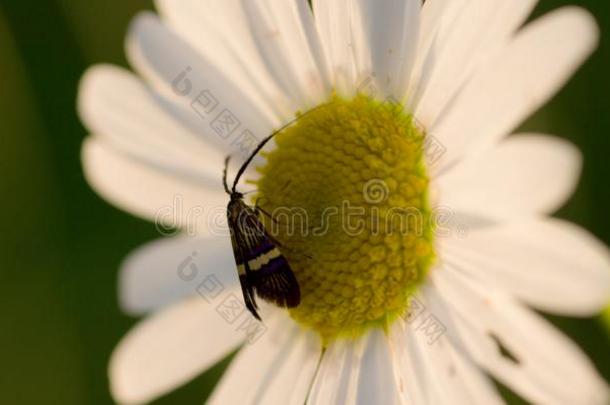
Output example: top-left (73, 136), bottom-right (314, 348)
top-left (0, 0), bottom-right (610, 405)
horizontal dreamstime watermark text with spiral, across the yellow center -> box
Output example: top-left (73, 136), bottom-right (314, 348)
top-left (155, 179), bottom-right (468, 237)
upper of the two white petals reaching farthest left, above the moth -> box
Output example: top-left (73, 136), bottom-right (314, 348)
top-left (78, 65), bottom-right (223, 179)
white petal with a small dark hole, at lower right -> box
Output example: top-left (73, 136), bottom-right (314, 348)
top-left (432, 269), bottom-right (610, 404)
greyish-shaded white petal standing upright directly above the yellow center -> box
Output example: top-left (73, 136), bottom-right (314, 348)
top-left (355, 0), bottom-right (422, 100)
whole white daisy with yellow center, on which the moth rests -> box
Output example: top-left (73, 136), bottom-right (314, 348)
top-left (79, 0), bottom-right (610, 405)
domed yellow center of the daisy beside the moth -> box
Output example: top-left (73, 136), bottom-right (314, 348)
top-left (257, 95), bottom-right (434, 342)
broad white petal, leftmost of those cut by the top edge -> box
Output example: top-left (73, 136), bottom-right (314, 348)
top-left (152, 0), bottom-right (298, 117)
